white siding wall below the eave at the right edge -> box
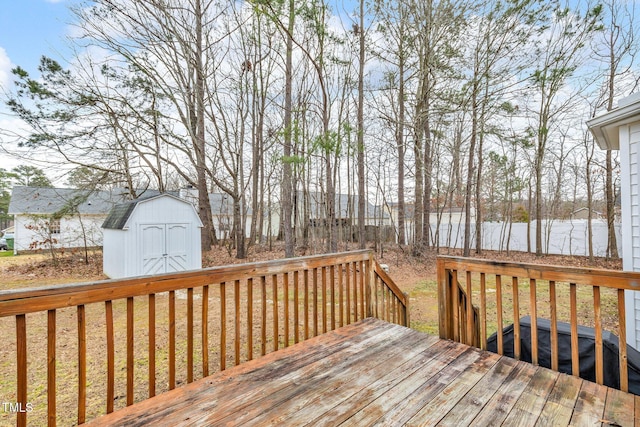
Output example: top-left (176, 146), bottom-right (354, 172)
top-left (619, 121), bottom-right (640, 349)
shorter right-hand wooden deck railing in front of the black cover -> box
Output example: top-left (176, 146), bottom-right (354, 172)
top-left (437, 256), bottom-right (640, 391)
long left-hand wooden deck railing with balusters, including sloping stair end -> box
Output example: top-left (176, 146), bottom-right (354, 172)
top-left (0, 251), bottom-right (409, 425)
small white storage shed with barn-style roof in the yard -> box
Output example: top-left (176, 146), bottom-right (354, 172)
top-left (102, 194), bottom-right (202, 279)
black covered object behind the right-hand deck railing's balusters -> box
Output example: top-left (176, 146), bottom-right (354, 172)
top-left (487, 316), bottom-right (640, 395)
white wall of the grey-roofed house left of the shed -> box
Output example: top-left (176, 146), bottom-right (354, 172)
top-left (14, 214), bottom-right (106, 253)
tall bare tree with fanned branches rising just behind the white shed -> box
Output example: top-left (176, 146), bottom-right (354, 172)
top-left (74, 0), bottom-right (226, 250)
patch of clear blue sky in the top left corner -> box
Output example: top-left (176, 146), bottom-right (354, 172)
top-left (0, 0), bottom-right (71, 79)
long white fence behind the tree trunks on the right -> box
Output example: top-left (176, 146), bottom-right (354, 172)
top-left (431, 219), bottom-right (622, 257)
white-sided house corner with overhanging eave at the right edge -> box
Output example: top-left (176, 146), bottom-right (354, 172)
top-left (587, 93), bottom-right (640, 350)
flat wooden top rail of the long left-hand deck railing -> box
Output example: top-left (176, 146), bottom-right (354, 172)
top-left (0, 250), bottom-right (371, 317)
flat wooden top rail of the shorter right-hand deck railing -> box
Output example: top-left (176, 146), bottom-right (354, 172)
top-left (437, 256), bottom-right (640, 290)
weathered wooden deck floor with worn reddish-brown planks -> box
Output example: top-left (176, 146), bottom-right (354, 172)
top-left (93, 318), bottom-right (640, 426)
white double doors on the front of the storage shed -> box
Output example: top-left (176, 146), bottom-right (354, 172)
top-left (141, 224), bottom-right (188, 275)
